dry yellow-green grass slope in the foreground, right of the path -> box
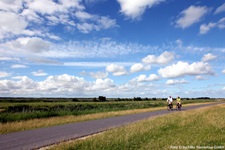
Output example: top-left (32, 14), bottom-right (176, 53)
top-left (50, 104), bottom-right (225, 150)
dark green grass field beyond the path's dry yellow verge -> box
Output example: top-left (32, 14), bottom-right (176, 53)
top-left (0, 101), bottom-right (165, 123)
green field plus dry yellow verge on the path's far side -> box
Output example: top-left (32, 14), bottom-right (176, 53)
top-left (0, 100), bottom-right (221, 134)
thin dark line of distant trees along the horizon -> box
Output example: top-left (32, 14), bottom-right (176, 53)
top-left (0, 96), bottom-right (214, 102)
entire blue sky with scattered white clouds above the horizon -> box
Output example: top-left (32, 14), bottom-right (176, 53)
top-left (0, 0), bottom-right (225, 98)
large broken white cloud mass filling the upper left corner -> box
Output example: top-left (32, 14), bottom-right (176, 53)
top-left (0, 0), bottom-right (118, 40)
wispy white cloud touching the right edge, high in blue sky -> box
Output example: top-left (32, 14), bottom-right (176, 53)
top-left (199, 17), bottom-right (225, 34)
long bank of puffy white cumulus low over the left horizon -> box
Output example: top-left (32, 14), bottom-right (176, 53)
top-left (0, 74), bottom-right (116, 97)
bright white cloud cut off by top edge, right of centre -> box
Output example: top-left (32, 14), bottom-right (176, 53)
top-left (117, 0), bottom-right (164, 19)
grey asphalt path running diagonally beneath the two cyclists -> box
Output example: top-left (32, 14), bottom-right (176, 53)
top-left (0, 102), bottom-right (222, 150)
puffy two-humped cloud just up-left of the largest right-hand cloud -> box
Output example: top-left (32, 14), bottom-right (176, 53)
top-left (142, 51), bottom-right (174, 65)
